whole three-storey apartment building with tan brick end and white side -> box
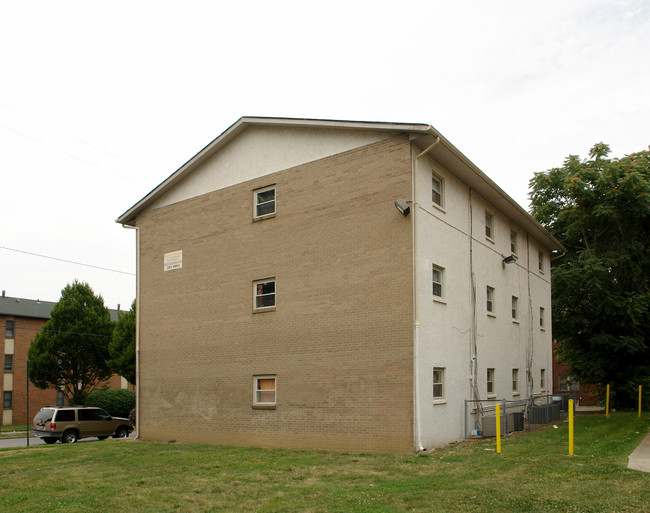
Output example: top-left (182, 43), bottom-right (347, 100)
top-left (117, 118), bottom-right (562, 451)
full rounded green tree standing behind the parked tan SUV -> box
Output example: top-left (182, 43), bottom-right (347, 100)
top-left (29, 281), bottom-right (113, 404)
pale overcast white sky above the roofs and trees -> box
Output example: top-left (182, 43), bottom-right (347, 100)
top-left (0, 0), bottom-right (650, 308)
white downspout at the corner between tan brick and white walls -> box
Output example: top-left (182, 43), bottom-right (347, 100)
top-left (412, 128), bottom-right (440, 451)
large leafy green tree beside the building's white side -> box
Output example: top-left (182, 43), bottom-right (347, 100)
top-left (530, 143), bottom-right (650, 403)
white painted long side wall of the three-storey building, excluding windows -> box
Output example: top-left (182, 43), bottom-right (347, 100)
top-left (417, 152), bottom-right (552, 447)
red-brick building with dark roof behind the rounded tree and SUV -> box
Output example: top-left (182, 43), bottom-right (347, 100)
top-left (0, 291), bottom-right (133, 425)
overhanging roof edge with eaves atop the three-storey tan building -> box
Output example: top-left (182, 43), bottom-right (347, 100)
top-left (116, 116), bottom-right (566, 251)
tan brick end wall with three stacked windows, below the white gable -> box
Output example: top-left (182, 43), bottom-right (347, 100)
top-left (137, 137), bottom-right (413, 451)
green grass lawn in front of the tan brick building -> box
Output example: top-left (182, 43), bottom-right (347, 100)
top-left (0, 413), bottom-right (650, 513)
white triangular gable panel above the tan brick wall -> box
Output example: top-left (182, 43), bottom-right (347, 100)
top-left (153, 126), bottom-right (391, 208)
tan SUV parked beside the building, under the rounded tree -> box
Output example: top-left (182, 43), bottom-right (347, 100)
top-left (32, 406), bottom-right (133, 444)
